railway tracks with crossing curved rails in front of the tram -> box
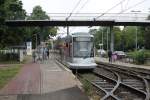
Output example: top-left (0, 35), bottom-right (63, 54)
top-left (80, 64), bottom-right (150, 100)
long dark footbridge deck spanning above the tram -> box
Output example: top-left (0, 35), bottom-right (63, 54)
top-left (5, 20), bottom-right (150, 27)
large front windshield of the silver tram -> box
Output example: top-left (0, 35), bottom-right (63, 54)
top-left (73, 37), bottom-right (94, 58)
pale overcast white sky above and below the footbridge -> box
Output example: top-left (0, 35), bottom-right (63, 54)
top-left (21, 0), bottom-right (150, 33)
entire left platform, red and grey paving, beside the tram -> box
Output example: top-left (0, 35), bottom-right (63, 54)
top-left (0, 54), bottom-right (89, 100)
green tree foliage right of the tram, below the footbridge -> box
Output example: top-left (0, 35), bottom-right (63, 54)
top-left (90, 26), bottom-right (146, 51)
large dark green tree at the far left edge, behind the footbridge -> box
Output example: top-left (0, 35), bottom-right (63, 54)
top-left (0, 0), bottom-right (26, 48)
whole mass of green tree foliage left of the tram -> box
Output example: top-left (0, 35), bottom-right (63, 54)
top-left (0, 0), bottom-right (57, 48)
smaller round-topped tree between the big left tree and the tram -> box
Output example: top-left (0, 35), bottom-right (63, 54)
top-left (28, 6), bottom-right (57, 48)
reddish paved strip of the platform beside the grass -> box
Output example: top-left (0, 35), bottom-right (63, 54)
top-left (0, 63), bottom-right (41, 95)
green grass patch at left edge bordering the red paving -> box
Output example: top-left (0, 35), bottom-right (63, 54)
top-left (0, 65), bottom-right (21, 89)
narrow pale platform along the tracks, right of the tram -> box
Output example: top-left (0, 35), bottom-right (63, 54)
top-left (95, 57), bottom-right (150, 70)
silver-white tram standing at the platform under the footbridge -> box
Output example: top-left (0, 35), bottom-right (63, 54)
top-left (57, 32), bottom-right (97, 69)
